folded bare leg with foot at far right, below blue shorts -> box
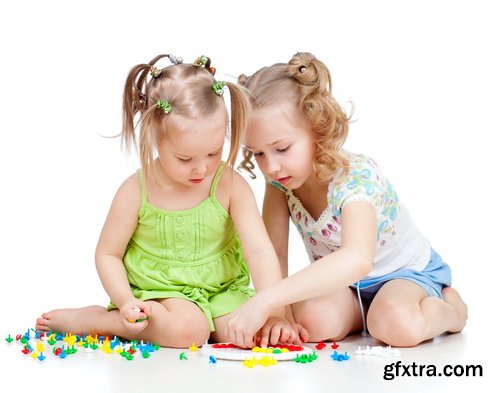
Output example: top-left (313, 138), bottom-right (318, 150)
top-left (367, 279), bottom-right (467, 347)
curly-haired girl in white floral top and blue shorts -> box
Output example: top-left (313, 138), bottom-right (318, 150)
top-left (227, 53), bottom-right (467, 347)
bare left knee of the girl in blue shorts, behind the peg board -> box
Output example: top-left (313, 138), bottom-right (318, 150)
top-left (292, 288), bottom-right (363, 342)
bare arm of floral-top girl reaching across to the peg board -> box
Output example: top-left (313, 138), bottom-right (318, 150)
top-left (226, 202), bottom-right (377, 345)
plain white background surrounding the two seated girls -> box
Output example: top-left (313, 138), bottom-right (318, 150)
top-left (0, 0), bottom-right (500, 358)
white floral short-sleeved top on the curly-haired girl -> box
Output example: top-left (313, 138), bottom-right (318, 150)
top-left (268, 152), bottom-right (431, 278)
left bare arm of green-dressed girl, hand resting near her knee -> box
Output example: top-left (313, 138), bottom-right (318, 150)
top-left (95, 175), bottom-right (150, 328)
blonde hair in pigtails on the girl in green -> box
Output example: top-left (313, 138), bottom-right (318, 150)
top-left (121, 55), bottom-right (249, 181)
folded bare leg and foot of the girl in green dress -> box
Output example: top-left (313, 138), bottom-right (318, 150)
top-left (36, 298), bottom-right (210, 348)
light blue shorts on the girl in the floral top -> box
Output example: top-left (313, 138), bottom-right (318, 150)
top-left (351, 248), bottom-right (451, 301)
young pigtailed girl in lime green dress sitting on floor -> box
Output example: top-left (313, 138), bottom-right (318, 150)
top-left (36, 55), bottom-right (297, 347)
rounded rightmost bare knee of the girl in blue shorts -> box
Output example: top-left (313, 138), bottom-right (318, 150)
top-left (366, 299), bottom-right (423, 347)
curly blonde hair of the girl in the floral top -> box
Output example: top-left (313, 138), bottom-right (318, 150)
top-left (238, 52), bottom-right (350, 182)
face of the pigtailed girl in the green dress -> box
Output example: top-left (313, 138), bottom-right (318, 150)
top-left (158, 111), bottom-right (226, 187)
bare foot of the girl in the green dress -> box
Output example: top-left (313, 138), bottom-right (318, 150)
top-left (35, 306), bottom-right (108, 334)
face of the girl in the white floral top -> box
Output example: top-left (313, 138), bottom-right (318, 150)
top-left (245, 104), bottom-right (315, 189)
